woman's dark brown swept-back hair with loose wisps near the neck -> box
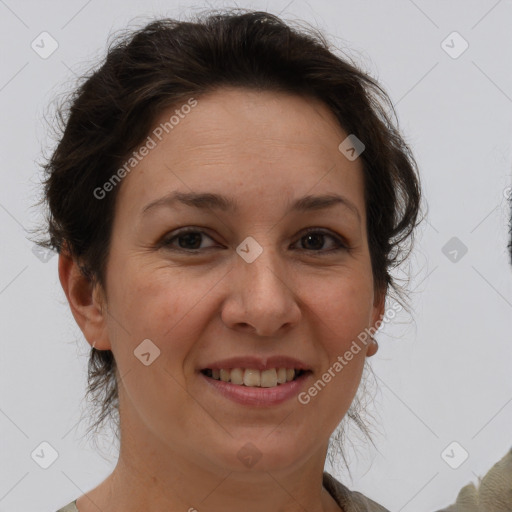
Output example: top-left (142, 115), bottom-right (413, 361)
top-left (34, 9), bottom-right (420, 470)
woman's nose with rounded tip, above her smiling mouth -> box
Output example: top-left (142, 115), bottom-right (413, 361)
top-left (221, 248), bottom-right (301, 337)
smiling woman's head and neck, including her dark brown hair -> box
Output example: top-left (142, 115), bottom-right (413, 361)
top-left (36, 8), bottom-right (420, 512)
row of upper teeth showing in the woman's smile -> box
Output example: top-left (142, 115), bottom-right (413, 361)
top-left (204, 368), bottom-right (299, 388)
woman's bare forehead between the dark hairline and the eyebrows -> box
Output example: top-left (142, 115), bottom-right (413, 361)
top-left (114, 88), bottom-right (364, 222)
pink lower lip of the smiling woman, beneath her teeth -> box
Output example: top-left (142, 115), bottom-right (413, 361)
top-left (199, 371), bottom-right (312, 407)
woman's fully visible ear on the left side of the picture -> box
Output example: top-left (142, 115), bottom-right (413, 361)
top-left (59, 249), bottom-right (111, 350)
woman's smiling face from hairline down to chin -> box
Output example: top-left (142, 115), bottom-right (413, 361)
top-left (91, 89), bottom-right (383, 471)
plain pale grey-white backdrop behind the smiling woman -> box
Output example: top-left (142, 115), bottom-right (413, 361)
top-left (0, 0), bottom-right (512, 512)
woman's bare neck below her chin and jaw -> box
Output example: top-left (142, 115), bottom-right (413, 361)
top-left (77, 412), bottom-right (341, 512)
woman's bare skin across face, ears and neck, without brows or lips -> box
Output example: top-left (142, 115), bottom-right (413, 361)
top-left (59, 88), bottom-right (384, 512)
